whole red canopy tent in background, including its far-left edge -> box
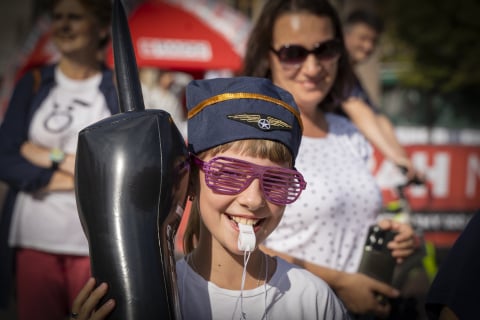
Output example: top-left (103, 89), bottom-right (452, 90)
top-left (0, 0), bottom-right (251, 118)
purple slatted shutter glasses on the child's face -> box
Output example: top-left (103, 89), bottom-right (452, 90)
top-left (192, 156), bottom-right (307, 205)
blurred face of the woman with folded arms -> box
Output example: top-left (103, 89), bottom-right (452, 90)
top-left (52, 0), bottom-right (108, 56)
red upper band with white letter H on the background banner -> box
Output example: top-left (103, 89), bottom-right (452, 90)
top-left (374, 145), bottom-right (480, 212)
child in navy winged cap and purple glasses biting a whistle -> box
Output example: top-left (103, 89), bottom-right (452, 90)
top-left (73, 77), bottom-right (348, 319)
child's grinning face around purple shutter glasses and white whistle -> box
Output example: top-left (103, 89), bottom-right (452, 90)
top-left (199, 150), bottom-right (289, 255)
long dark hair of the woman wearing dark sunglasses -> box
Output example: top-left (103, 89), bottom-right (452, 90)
top-left (243, 0), bottom-right (353, 109)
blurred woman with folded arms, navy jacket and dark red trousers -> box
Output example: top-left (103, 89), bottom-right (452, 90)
top-left (0, 0), bottom-right (118, 320)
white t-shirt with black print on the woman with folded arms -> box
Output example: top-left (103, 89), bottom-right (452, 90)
top-left (9, 67), bottom-right (110, 255)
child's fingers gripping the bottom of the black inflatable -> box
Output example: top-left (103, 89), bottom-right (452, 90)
top-left (70, 278), bottom-right (115, 320)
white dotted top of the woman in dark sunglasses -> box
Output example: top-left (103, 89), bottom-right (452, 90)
top-left (265, 113), bottom-right (382, 272)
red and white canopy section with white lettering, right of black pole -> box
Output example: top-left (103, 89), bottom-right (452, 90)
top-left (107, 0), bottom-right (250, 75)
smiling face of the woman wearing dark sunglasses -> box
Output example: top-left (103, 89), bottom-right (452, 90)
top-left (269, 13), bottom-right (339, 112)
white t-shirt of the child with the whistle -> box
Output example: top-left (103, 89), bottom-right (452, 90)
top-left (177, 258), bottom-right (349, 320)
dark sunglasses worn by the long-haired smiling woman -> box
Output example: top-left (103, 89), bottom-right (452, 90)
top-left (270, 39), bottom-right (343, 64)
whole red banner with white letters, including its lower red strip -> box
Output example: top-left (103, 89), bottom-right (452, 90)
top-left (373, 145), bottom-right (480, 246)
